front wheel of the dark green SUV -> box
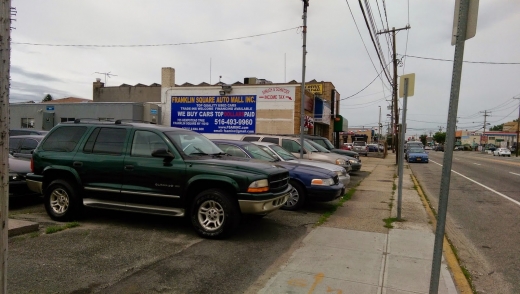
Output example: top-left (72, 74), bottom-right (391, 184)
top-left (191, 189), bottom-right (240, 239)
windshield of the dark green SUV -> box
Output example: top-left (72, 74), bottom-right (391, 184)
top-left (164, 131), bottom-right (223, 155)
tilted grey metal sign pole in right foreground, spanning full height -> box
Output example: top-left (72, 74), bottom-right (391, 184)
top-left (429, 0), bottom-right (469, 294)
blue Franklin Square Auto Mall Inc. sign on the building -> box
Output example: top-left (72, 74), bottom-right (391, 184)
top-left (171, 95), bottom-right (256, 134)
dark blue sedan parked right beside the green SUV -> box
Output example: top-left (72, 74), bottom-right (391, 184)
top-left (211, 140), bottom-right (345, 210)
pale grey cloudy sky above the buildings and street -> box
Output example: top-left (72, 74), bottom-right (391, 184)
top-left (10, 0), bottom-right (520, 134)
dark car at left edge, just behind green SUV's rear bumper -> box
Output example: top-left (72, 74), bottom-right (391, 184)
top-left (9, 154), bottom-right (38, 197)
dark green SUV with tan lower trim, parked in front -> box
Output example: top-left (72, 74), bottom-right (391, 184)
top-left (27, 120), bottom-right (291, 238)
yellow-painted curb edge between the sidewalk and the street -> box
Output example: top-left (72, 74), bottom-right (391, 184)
top-left (411, 173), bottom-right (473, 293)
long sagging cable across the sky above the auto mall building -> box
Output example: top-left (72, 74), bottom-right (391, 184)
top-left (11, 26), bottom-right (301, 48)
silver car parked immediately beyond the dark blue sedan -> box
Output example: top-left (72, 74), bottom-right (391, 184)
top-left (252, 142), bottom-right (350, 187)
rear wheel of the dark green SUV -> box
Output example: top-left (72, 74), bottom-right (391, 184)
top-left (43, 180), bottom-right (83, 221)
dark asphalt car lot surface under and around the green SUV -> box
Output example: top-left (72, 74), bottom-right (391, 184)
top-left (7, 171), bottom-right (368, 294)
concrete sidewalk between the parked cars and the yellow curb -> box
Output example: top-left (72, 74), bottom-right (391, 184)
top-left (259, 153), bottom-right (462, 294)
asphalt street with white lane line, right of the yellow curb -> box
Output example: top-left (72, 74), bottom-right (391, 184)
top-left (410, 151), bottom-right (520, 293)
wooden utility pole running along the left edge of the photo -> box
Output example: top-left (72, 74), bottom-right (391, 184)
top-left (0, 0), bottom-right (11, 294)
